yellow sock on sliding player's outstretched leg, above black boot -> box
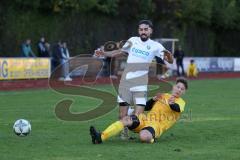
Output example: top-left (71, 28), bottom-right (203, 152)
top-left (101, 121), bottom-right (124, 141)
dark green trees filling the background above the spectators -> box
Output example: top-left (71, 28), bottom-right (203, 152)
top-left (0, 0), bottom-right (240, 56)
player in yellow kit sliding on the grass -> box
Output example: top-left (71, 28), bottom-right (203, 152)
top-left (90, 78), bottom-right (188, 144)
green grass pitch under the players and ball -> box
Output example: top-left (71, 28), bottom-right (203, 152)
top-left (0, 79), bottom-right (240, 160)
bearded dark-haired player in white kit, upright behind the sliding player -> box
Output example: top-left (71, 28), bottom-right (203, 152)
top-left (95, 20), bottom-right (173, 138)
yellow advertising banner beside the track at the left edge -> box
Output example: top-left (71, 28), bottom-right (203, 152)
top-left (0, 58), bottom-right (51, 80)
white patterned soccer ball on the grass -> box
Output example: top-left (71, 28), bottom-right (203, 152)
top-left (13, 119), bottom-right (31, 137)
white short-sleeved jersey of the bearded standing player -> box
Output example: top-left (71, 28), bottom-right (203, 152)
top-left (122, 37), bottom-right (165, 91)
